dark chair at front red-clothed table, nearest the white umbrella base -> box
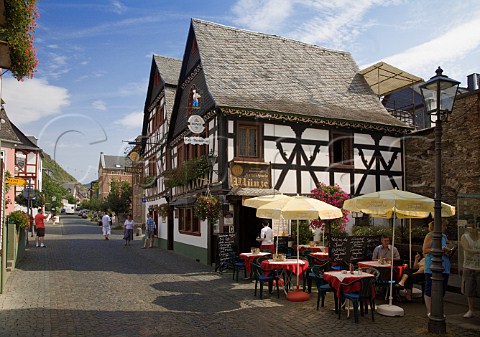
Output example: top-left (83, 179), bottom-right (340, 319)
top-left (338, 277), bottom-right (376, 323)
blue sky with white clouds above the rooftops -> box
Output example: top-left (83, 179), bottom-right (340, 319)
top-left (1, 0), bottom-right (480, 183)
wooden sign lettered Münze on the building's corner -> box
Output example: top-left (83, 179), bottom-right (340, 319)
top-left (229, 161), bottom-right (272, 188)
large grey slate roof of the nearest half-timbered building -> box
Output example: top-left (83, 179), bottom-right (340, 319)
top-left (192, 19), bottom-right (408, 128)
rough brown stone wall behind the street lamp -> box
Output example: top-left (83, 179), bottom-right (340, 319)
top-left (405, 90), bottom-right (480, 205)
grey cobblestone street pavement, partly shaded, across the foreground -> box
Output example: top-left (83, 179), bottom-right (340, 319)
top-left (0, 216), bottom-right (480, 337)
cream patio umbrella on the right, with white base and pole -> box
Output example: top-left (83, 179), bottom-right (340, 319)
top-left (343, 189), bottom-right (455, 316)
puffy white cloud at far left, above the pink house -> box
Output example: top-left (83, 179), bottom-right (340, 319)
top-left (2, 78), bottom-right (70, 126)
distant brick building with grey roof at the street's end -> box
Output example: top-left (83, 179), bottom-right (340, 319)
top-left (98, 152), bottom-right (132, 199)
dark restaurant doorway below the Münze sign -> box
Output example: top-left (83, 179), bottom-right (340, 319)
top-left (238, 203), bottom-right (262, 253)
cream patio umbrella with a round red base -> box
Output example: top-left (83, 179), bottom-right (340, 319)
top-left (257, 196), bottom-right (343, 301)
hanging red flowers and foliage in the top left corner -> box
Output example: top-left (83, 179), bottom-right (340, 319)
top-left (0, 0), bottom-right (39, 81)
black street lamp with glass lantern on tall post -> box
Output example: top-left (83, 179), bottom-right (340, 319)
top-left (420, 67), bottom-right (460, 334)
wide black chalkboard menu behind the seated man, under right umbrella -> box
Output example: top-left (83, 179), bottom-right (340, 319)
top-left (328, 235), bottom-right (380, 262)
